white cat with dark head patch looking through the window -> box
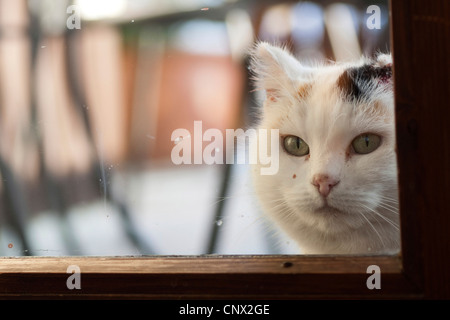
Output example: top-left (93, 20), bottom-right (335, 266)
top-left (250, 42), bottom-right (400, 254)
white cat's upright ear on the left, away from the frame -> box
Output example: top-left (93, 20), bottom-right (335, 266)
top-left (250, 42), bottom-right (303, 101)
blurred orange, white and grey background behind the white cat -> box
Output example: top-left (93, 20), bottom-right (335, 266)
top-left (0, 0), bottom-right (389, 256)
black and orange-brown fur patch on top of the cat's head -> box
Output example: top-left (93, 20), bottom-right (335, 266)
top-left (337, 64), bottom-right (392, 101)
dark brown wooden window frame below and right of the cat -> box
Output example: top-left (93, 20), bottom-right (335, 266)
top-left (0, 0), bottom-right (450, 299)
